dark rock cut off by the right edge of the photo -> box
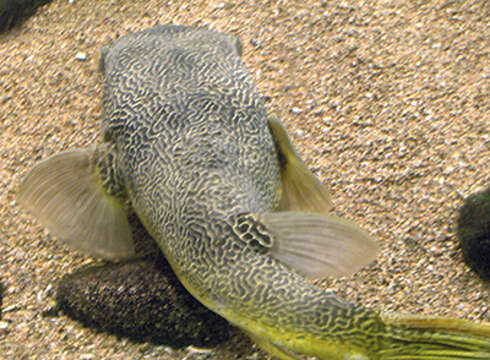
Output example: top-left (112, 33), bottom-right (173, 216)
top-left (457, 186), bottom-right (490, 281)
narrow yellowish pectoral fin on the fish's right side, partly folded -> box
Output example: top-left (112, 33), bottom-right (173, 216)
top-left (268, 116), bottom-right (332, 213)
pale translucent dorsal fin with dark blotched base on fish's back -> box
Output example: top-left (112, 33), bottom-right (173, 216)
top-left (259, 211), bottom-right (377, 279)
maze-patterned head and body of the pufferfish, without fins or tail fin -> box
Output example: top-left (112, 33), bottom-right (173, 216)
top-left (99, 25), bottom-right (383, 358)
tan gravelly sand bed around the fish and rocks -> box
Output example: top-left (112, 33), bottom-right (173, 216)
top-left (0, 0), bottom-right (490, 360)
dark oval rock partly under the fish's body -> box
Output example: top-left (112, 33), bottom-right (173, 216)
top-left (56, 255), bottom-right (234, 347)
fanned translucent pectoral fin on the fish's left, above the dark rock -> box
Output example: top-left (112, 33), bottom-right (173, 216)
top-left (18, 147), bottom-right (134, 260)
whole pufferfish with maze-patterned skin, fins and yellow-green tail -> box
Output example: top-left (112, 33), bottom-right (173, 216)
top-left (19, 25), bottom-right (490, 360)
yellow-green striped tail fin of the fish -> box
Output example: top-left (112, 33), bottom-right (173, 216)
top-left (376, 313), bottom-right (490, 360)
